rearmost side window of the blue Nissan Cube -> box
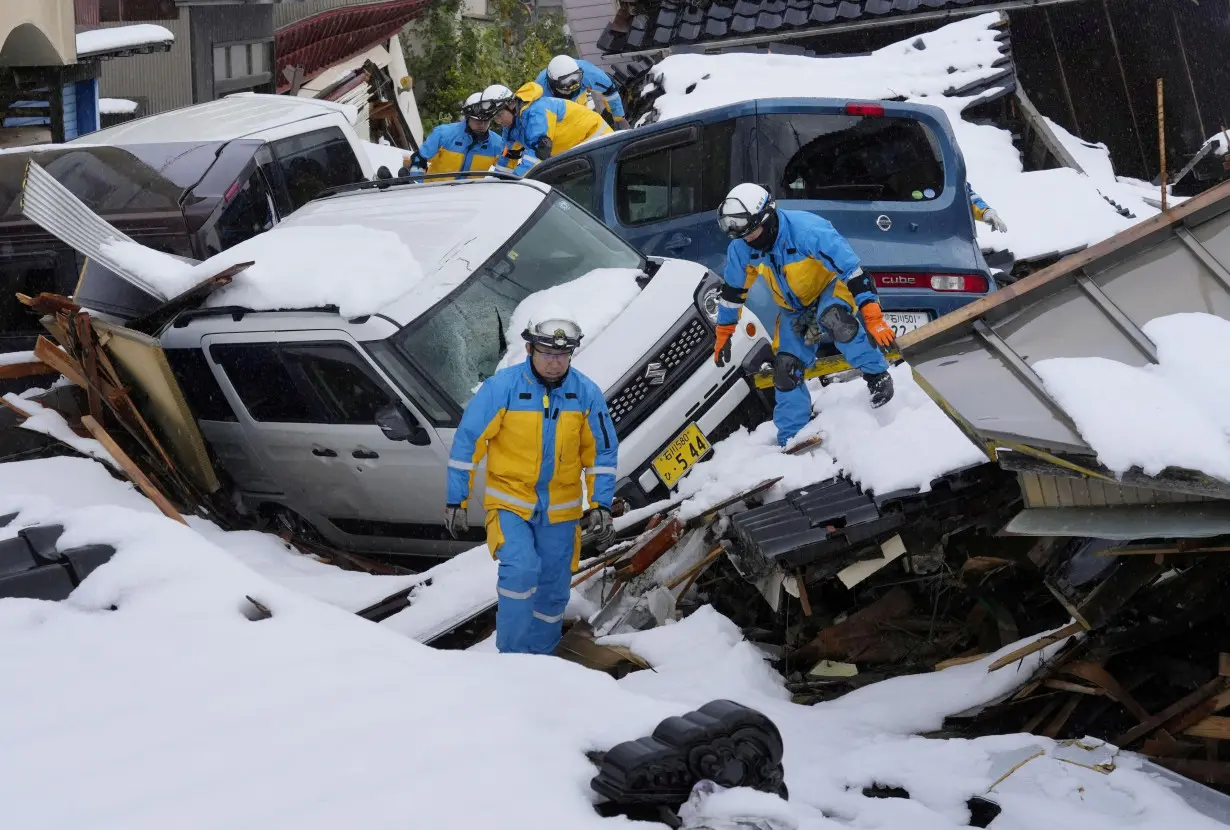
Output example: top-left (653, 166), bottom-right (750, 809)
top-left (615, 119), bottom-right (734, 226)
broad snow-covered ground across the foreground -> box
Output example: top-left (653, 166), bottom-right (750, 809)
top-left (0, 459), bottom-right (1221, 830)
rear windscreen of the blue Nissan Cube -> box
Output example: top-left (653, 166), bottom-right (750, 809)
top-left (759, 113), bottom-right (943, 202)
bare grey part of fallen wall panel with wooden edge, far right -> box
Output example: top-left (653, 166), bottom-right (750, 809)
top-left (899, 183), bottom-right (1230, 467)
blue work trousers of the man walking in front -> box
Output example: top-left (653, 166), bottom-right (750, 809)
top-left (487, 510), bottom-right (581, 654)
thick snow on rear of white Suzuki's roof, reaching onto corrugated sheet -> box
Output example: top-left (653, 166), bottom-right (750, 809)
top-left (103, 225), bottom-right (423, 317)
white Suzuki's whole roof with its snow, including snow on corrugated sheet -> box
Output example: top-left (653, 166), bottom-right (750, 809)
top-left (105, 180), bottom-right (551, 325)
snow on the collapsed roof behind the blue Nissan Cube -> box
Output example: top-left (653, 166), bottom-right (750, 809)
top-left (654, 14), bottom-right (1157, 259)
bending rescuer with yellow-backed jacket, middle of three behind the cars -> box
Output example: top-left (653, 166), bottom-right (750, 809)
top-left (482, 81), bottom-right (613, 178)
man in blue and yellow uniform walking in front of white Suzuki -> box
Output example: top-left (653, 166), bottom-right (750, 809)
top-left (445, 310), bottom-right (619, 654)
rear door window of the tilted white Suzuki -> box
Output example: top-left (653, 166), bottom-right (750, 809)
top-left (209, 343), bottom-right (314, 423)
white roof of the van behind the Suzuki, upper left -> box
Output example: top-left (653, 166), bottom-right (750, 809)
top-left (69, 93), bottom-right (358, 146)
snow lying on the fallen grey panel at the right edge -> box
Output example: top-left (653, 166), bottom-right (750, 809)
top-left (1033, 312), bottom-right (1230, 481)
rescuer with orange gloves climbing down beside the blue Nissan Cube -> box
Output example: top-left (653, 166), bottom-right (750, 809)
top-left (713, 183), bottom-right (894, 446)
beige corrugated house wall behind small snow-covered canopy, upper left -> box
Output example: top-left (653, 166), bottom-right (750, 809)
top-left (98, 6), bottom-right (192, 116)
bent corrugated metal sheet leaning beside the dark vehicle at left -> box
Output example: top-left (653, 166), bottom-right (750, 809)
top-left (21, 161), bottom-right (166, 299)
